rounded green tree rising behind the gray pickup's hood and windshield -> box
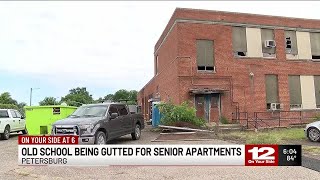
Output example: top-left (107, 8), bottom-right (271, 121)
top-left (61, 87), bottom-right (94, 107)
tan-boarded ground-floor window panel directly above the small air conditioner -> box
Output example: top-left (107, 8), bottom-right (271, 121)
top-left (266, 75), bottom-right (278, 104)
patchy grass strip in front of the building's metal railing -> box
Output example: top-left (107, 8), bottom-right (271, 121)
top-left (221, 128), bottom-right (305, 144)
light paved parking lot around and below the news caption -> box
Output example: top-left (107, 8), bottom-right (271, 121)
top-left (0, 128), bottom-right (320, 180)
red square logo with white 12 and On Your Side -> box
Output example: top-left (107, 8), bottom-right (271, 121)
top-left (245, 145), bottom-right (278, 166)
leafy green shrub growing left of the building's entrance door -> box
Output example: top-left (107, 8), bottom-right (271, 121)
top-left (157, 102), bottom-right (205, 127)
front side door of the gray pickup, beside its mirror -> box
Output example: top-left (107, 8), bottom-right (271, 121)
top-left (108, 105), bottom-right (123, 138)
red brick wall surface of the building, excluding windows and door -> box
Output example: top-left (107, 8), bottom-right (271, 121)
top-left (139, 9), bottom-right (320, 125)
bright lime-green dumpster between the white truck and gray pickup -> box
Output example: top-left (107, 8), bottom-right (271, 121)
top-left (24, 105), bottom-right (77, 135)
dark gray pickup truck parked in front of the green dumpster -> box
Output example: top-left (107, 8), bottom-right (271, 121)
top-left (51, 103), bottom-right (144, 144)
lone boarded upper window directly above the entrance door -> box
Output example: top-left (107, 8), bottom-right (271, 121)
top-left (197, 40), bottom-right (214, 71)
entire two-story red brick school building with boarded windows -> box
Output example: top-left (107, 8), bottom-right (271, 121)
top-left (138, 8), bottom-right (320, 126)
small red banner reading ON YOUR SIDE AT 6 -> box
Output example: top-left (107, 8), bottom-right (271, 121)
top-left (18, 136), bottom-right (79, 144)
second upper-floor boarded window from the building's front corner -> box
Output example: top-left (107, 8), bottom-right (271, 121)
top-left (232, 27), bottom-right (247, 56)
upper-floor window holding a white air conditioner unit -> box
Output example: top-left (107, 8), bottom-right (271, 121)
top-left (261, 29), bottom-right (276, 57)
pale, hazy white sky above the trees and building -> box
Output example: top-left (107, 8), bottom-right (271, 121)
top-left (0, 1), bottom-right (320, 105)
